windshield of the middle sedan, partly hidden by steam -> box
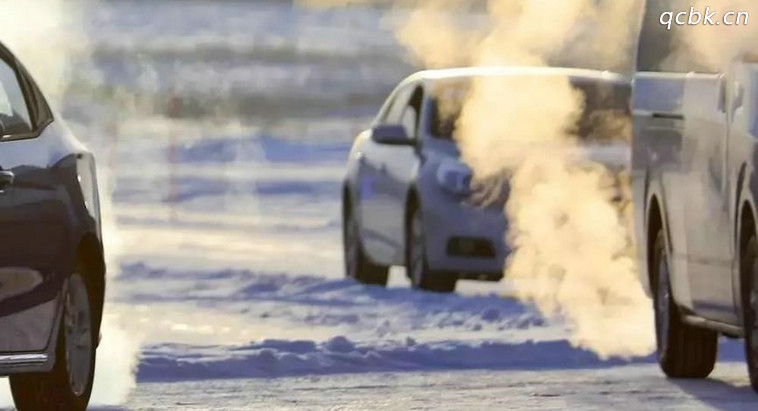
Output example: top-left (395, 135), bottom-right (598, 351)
top-left (429, 82), bottom-right (631, 140)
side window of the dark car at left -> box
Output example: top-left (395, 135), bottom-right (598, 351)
top-left (0, 60), bottom-right (32, 135)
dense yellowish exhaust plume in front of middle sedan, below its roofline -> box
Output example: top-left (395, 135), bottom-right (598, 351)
top-left (458, 72), bottom-right (654, 357)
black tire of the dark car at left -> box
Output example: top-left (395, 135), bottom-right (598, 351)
top-left (10, 274), bottom-right (97, 411)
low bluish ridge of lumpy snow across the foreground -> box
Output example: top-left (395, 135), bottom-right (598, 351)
top-left (137, 336), bottom-right (653, 381)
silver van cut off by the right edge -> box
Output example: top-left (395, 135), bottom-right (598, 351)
top-left (632, 2), bottom-right (758, 390)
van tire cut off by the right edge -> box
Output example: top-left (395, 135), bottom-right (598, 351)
top-left (740, 234), bottom-right (758, 392)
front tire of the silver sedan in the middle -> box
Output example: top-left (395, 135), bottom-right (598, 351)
top-left (405, 207), bottom-right (458, 293)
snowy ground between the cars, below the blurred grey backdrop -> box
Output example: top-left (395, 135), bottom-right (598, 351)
top-left (55, 101), bottom-right (758, 410)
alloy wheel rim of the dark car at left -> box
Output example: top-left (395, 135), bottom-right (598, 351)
top-left (64, 277), bottom-right (92, 396)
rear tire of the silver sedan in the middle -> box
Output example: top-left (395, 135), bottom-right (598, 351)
top-left (342, 203), bottom-right (389, 287)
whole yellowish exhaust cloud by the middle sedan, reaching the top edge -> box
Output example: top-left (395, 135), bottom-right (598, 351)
top-left (307, 0), bottom-right (655, 358)
